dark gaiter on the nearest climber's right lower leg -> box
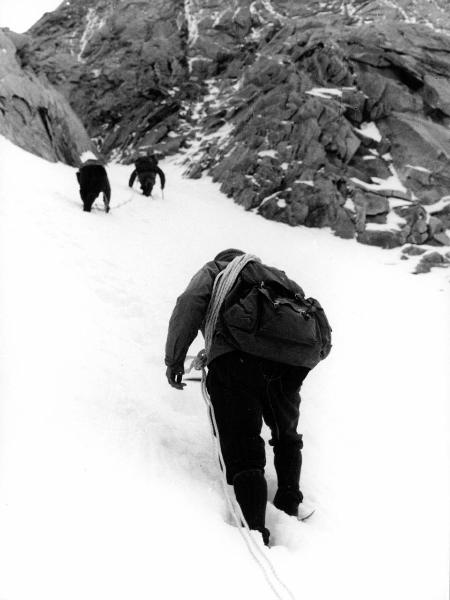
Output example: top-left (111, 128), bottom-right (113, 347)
top-left (273, 436), bottom-right (303, 516)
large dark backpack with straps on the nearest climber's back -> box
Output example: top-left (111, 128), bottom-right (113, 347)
top-left (217, 262), bottom-right (331, 369)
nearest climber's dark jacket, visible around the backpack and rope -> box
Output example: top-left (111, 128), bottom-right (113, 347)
top-left (165, 261), bottom-right (303, 368)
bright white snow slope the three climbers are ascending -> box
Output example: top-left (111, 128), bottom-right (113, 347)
top-left (0, 140), bottom-right (450, 600)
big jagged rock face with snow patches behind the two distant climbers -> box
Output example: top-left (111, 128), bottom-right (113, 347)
top-left (22, 0), bottom-right (450, 248)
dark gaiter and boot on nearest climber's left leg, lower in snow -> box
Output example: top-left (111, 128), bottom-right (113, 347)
top-left (233, 469), bottom-right (270, 546)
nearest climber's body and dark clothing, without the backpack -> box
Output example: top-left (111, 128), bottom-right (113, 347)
top-left (165, 249), bottom-right (309, 544)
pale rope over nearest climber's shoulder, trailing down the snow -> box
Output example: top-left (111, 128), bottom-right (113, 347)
top-left (195, 254), bottom-right (295, 600)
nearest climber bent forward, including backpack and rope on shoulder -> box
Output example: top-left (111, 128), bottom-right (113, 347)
top-left (165, 248), bottom-right (331, 545)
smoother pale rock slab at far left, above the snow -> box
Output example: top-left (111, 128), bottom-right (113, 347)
top-left (0, 30), bottom-right (92, 165)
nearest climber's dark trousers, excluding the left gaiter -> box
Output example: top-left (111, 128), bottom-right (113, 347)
top-left (206, 352), bottom-right (309, 512)
